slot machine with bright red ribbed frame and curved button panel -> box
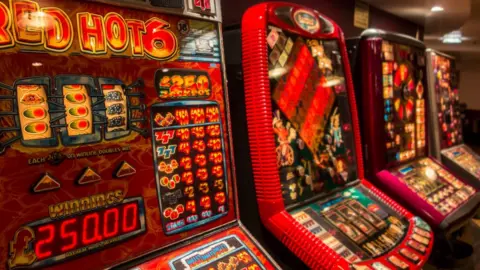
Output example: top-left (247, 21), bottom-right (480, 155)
top-left (242, 2), bottom-right (433, 269)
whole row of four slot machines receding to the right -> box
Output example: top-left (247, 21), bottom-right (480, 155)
top-left (0, 0), bottom-right (480, 270)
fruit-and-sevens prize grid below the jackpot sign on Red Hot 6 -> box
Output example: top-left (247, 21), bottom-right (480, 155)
top-left (152, 101), bottom-right (228, 234)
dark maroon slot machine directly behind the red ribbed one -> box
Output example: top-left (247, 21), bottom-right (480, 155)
top-left (351, 29), bottom-right (479, 231)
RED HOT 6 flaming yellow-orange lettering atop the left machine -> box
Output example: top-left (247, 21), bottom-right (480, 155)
top-left (0, 0), bottom-right (178, 60)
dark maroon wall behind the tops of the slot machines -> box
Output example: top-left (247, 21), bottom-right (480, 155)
top-left (222, 0), bottom-right (423, 38)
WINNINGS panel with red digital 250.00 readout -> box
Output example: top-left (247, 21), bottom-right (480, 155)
top-left (8, 190), bottom-right (145, 269)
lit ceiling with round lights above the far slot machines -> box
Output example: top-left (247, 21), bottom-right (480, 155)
top-left (365, 0), bottom-right (480, 61)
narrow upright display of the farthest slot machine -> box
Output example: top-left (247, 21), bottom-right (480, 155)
top-left (431, 54), bottom-right (463, 149)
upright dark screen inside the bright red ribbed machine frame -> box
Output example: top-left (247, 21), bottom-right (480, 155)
top-left (267, 26), bottom-right (357, 205)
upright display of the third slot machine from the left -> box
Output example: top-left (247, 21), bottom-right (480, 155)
top-left (382, 41), bottom-right (426, 164)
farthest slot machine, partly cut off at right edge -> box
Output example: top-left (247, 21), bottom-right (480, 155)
top-left (427, 49), bottom-right (480, 189)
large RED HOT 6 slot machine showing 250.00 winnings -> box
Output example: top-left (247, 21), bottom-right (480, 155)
top-left (0, 0), bottom-right (277, 270)
